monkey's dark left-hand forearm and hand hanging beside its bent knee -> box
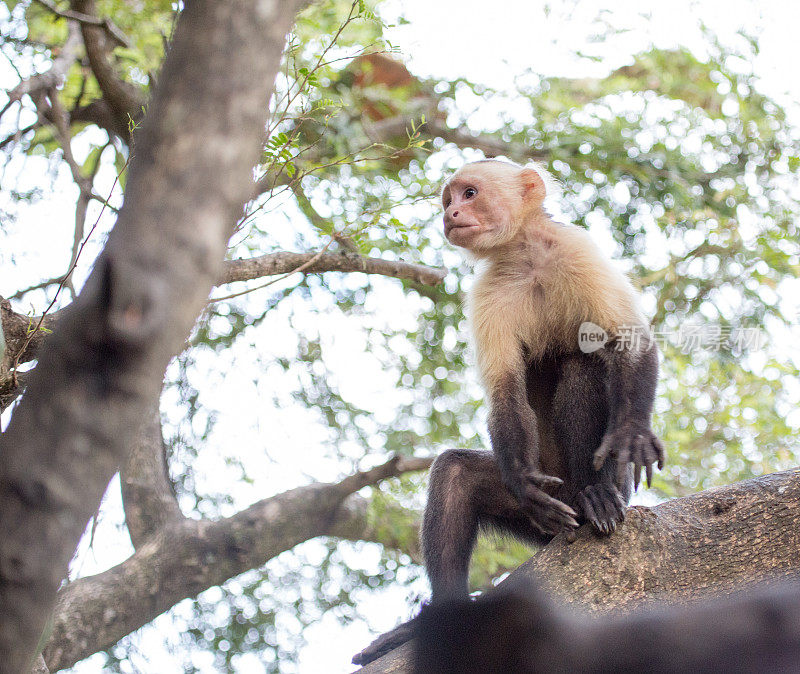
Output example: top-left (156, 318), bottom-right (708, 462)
top-left (489, 370), bottom-right (578, 534)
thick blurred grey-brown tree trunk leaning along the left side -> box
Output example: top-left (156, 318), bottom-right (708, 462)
top-left (0, 0), bottom-right (302, 673)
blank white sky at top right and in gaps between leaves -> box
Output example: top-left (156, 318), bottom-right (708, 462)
top-left (0, 0), bottom-right (800, 674)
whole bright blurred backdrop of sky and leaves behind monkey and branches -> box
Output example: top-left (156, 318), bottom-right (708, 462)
top-left (0, 0), bottom-right (800, 673)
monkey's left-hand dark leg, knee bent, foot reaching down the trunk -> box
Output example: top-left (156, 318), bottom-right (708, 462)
top-left (353, 449), bottom-right (552, 665)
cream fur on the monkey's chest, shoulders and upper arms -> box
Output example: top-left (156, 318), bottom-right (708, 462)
top-left (467, 223), bottom-right (644, 387)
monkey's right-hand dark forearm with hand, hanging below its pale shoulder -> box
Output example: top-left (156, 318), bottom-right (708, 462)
top-left (594, 340), bottom-right (664, 488)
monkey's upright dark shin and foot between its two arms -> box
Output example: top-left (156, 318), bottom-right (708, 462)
top-left (552, 353), bottom-right (630, 534)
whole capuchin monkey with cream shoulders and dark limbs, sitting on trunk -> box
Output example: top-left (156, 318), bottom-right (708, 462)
top-left (353, 160), bottom-right (664, 664)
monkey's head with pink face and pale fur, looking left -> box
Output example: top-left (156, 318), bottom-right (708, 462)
top-left (442, 159), bottom-right (546, 256)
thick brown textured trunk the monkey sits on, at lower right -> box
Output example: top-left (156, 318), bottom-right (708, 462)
top-left (359, 470), bottom-right (800, 674)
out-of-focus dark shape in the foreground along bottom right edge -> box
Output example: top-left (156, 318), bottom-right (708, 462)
top-left (413, 581), bottom-right (800, 674)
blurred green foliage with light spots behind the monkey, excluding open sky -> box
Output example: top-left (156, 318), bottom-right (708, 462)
top-left (3, 0), bottom-right (800, 672)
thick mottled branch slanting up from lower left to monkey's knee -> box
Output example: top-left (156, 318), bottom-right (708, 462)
top-left (44, 457), bottom-right (431, 671)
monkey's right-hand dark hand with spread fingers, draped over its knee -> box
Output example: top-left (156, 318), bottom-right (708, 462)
top-left (594, 421), bottom-right (664, 489)
